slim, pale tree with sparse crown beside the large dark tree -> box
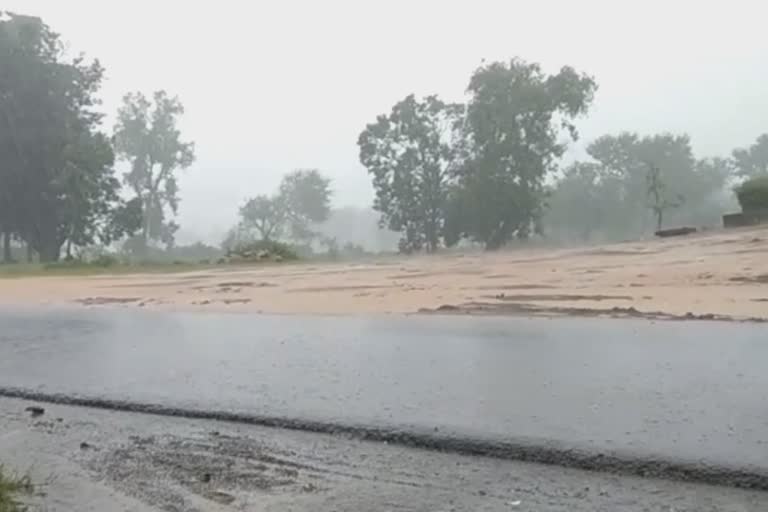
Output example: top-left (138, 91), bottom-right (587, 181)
top-left (114, 91), bottom-right (195, 252)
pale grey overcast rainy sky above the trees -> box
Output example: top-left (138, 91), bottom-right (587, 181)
top-left (2, 0), bottom-right (768, 241)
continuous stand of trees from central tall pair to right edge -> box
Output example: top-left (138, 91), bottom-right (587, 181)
top-left (358, 59), bottom-right (768, 252)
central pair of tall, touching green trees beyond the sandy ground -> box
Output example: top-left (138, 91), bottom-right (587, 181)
top-left (358, 59), bottom-right (597, 252)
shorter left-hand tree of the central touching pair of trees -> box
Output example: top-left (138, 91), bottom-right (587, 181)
top-left (358, 95), bottom-right (464, 252)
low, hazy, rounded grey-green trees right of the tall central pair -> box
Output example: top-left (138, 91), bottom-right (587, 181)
top-left (545, 132), bottom-right (732, 240)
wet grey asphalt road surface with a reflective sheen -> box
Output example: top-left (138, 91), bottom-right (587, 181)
top-left (0, 309), bottom-right (768, 469)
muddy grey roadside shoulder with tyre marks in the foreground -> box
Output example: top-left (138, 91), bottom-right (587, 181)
top-left (0, 398), bottom-right (768, 512)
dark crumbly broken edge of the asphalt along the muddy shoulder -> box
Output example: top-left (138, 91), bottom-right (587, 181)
top-left (0, 387), bottom-right (768, 491)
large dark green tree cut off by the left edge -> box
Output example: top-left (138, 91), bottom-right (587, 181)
top-left (0, 13), bottom-right (136, 260)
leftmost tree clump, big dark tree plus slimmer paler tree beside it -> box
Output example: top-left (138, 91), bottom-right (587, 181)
top-left (0, 12), bottom-right (194, 262)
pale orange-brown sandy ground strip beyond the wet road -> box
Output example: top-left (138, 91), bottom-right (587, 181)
top-left (0, 227), bottom-right (768, 319)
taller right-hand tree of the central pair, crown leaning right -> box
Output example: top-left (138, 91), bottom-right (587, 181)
top-left (451, 59), bottom-right (597, 249)
